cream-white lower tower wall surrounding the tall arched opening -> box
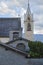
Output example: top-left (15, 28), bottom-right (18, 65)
top-left (24, 22), bottom-right (33, 41)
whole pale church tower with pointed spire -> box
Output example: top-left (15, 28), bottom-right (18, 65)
top-left (24, 1), bottom-right (33, 41)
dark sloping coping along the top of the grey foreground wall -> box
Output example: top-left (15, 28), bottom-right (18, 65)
top-left (0, 44), bottom-right (29, 56)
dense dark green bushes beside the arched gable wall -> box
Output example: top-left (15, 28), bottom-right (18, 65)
top-left (28, 41), bottom-right (43, 58)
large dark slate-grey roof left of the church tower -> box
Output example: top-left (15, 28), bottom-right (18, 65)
top-left (0, 18), bottom-right (21, 37)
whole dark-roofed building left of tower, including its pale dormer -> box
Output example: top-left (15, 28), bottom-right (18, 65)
top-left (0, 17), bottom-right (22, 41)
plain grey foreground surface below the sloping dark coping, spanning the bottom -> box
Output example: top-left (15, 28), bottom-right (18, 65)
top-left (0, 47), bottom-right (43, 65)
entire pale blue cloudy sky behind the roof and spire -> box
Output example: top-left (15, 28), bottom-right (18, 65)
top-left (0, 0), bottom-right (43, 34)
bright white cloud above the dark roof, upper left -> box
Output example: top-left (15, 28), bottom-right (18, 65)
top-left (0, 1), bottom-right (18, 17)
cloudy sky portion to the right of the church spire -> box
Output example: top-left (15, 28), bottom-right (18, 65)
top-left (30, 0), bottom-right (43, 34)
